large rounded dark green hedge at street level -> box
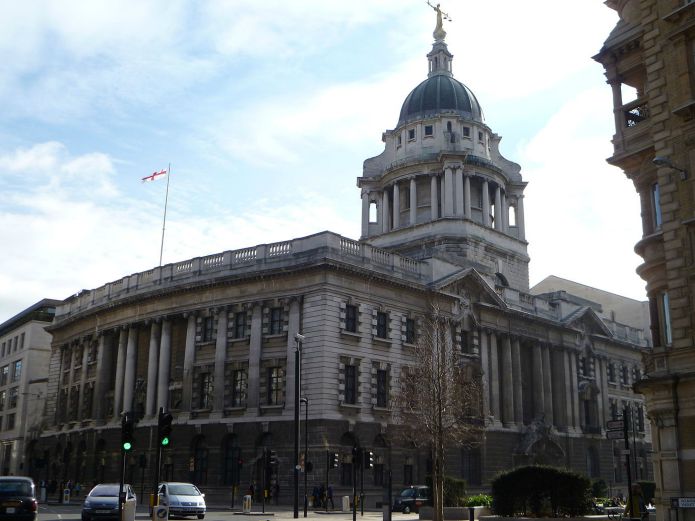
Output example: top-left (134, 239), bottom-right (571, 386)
top-left (492, 466), bottom-right (591, 517)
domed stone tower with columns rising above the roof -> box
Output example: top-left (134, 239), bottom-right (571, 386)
top-left (357, 20), bottom-right (529, 290)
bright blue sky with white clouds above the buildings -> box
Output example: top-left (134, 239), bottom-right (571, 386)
top-left (0, 0), bottom-right (645, 323)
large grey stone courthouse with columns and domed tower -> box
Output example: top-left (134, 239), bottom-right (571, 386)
top-left (27, 13), bottom-right (651, 500)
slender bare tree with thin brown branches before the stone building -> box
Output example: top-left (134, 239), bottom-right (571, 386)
top-left (396, 305), bottom-right (484, 521)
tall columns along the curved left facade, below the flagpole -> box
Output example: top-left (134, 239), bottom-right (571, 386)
top-left (57, 299), bottom-right (301, 420)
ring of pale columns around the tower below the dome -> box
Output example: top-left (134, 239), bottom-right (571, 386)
top-left (362, 164), bottom-right (525, 239)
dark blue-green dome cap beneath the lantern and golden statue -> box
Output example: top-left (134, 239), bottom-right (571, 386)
top-left (397, 74), bottom-right (483, 127)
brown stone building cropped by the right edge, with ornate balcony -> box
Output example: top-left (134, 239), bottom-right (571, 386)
top-left (595, 0), bottom-right (695, 520)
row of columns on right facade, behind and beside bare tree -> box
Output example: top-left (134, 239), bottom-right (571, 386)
top-left (479, 329), bottom-right (608, 431)
